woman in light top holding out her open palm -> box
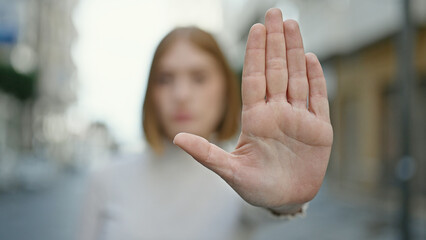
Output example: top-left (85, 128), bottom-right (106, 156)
top-left (79, 9), bottom-right (332, 239)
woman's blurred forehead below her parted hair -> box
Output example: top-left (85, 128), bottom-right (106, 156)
top-left (160, 40), bottom-right (217, 70)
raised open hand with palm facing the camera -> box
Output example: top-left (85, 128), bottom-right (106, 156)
top-left (174, 9), bottom-right (333, 213)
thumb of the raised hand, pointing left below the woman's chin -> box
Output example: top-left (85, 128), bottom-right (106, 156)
top-left (173, 133), bottom-right (233, 179)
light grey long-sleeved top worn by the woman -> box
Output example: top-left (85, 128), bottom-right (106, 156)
top-left (77, 141), bottom-right (302, 240)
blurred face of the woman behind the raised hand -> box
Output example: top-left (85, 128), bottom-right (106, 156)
top-left (154, 40), bottom-right (225, 139)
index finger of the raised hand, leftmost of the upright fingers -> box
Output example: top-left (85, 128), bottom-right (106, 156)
top-left (241, 23), bottom-right (266, 108)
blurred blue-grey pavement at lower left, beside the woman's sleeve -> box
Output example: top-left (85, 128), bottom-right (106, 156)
top-left (0, 170), bottom-right (84, 240)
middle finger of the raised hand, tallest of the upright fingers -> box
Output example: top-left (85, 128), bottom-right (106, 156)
top-left (265, 8), bottom-right (287, 100)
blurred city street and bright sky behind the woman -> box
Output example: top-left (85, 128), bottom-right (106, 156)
top-left (0, 0), bottom-right (426, 240)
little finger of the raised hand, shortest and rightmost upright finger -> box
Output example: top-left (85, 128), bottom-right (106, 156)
top-left (306, 53), bottom-right (330, 122)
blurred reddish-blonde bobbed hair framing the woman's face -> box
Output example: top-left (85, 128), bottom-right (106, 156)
top-left (142, 27), bottom-right (241, 154)
